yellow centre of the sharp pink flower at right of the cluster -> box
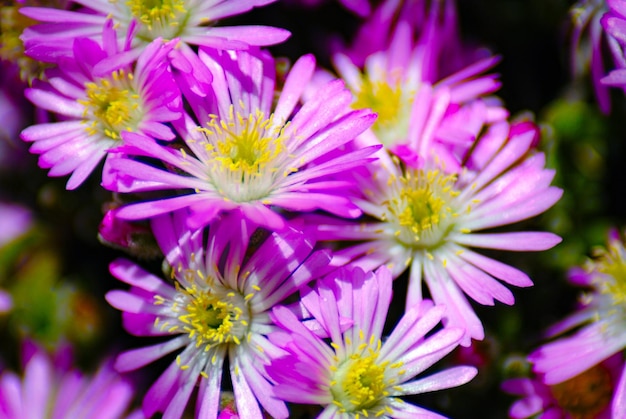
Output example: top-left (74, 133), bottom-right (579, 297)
top-left (383, 170), bottom-right (459, 249)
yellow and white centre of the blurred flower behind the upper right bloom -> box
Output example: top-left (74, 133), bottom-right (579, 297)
top-left (352, 76), bottom-right (415, 147)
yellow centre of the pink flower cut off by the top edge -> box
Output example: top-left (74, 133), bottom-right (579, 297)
top-left (126, 0), bottom-right (189, 42)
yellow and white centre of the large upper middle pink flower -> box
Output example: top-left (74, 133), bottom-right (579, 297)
top-left (200, 106), bottom-right (290, 202)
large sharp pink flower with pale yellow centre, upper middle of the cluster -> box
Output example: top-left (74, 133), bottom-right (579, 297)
top-left (103, 49), bottom-right (379, 229)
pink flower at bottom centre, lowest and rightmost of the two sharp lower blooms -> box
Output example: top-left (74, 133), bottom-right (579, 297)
top-left (267, 267), bottom-right (476, 418)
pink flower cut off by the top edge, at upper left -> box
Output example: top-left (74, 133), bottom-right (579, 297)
top-left (20, 0), bottom-right (290, 61)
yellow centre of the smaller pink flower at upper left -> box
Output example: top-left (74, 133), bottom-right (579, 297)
top-left (78, 70), bottom-right (142, 140)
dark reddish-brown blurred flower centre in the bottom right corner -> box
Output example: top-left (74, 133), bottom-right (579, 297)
top-left (550, 365), bottom-right (613, 419)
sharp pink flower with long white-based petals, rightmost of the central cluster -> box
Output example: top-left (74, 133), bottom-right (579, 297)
top-left (305, 124), bottom-right (562, 346)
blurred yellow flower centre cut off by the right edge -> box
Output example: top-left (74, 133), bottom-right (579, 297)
top-left (592, 240), bottom-right (626, 306)
